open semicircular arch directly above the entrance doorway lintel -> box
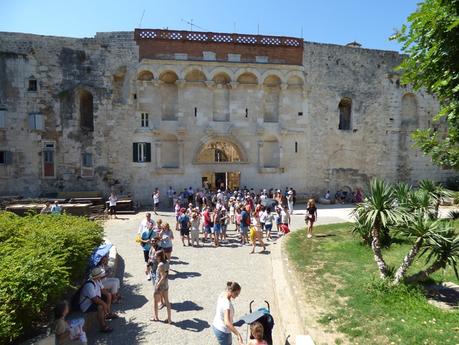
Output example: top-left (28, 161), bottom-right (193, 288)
top-left (193, 136), bottom-right (247, 164)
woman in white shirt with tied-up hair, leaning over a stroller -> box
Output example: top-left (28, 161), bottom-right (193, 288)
top-left (212, 282), bottom-right (243, 345)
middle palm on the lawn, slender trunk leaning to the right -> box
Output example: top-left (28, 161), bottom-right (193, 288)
top-left (393, 210), bottom-right (441, 285)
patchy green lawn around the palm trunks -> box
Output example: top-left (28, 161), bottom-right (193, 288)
top-left (286, 222), bottom-right (459, 345)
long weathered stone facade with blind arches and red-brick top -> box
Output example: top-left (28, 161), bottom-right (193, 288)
top-left (0, 29), bottom-right (452, 201)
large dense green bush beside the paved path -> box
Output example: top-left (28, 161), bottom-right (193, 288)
top-left (0, 212), bottom-right (103, 343)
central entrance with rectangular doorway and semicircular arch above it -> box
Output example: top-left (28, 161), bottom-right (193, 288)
top-left (195, 140), bottom-right (245, 190)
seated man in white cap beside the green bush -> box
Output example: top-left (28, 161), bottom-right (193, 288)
top-left (79, 266), bottom-right (118, 333)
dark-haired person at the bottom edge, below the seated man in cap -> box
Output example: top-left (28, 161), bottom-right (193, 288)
top-left (54, 301), bottom-right (87, 345)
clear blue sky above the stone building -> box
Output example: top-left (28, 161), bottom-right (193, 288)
top-left (0, 0), bottom-right (419, 50)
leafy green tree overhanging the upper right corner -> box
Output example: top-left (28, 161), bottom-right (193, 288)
top-left (391, 0), bottom-right (459, 170)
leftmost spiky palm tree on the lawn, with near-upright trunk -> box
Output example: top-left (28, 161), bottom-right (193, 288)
top-left (354, 179), bottom-right (401, 278)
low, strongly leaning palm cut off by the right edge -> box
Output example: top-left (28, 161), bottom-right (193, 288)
top-left (406, 223), bottom-right (459, 283)
